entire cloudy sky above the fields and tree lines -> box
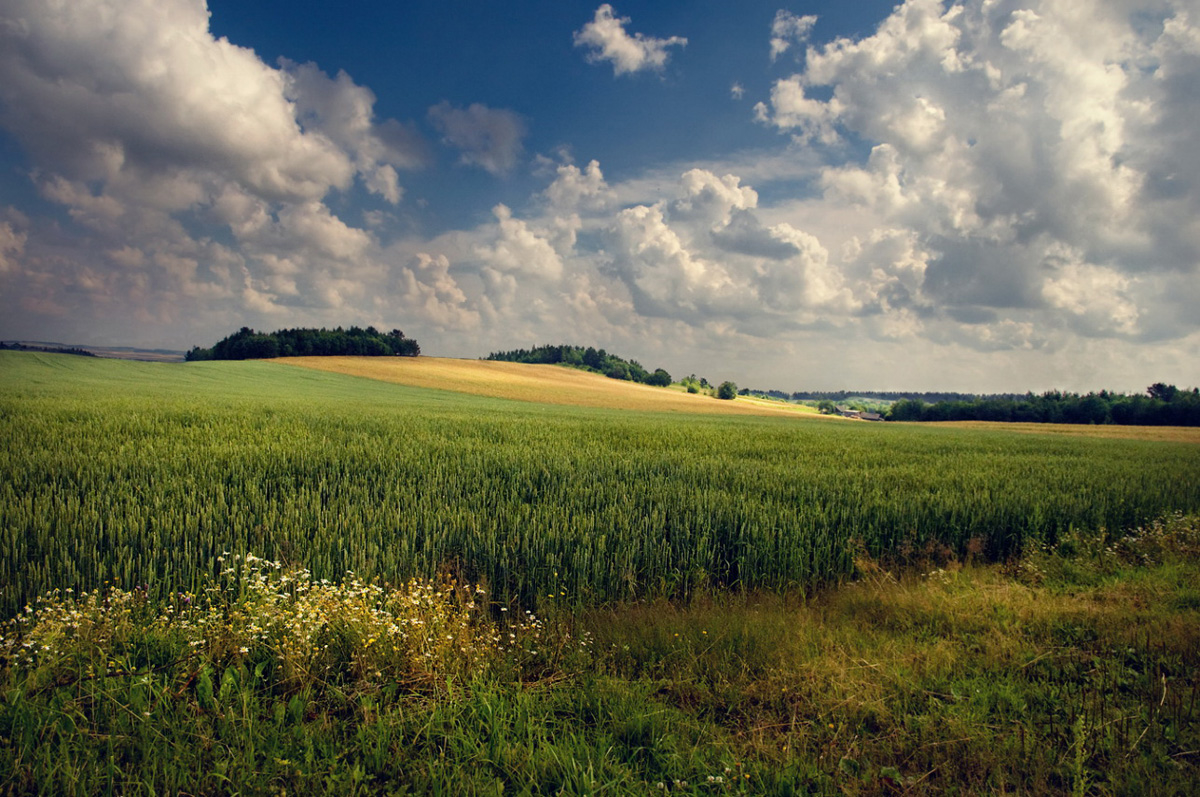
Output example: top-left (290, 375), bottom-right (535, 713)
top-left (0, 0), bottom-right (1200, 392)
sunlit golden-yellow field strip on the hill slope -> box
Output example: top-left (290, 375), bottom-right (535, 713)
top-left (275, 356), bottom-right (835, 418)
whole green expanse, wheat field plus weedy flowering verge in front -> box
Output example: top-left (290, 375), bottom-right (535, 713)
top-left (0, 352), bottom-right (1200, 795)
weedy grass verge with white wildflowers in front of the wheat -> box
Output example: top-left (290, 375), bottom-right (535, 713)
top-left (0, 516), bottom-right (1200, 795)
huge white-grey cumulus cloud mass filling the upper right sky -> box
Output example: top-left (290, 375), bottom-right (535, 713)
top-left (757, 0), bottom-right (1200, 348)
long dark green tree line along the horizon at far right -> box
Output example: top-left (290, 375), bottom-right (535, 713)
top-left (887, 382), bottom-right (1200, 426)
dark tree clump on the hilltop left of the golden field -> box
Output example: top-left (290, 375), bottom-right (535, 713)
top-left (185, 326), bottom-right (421, 361)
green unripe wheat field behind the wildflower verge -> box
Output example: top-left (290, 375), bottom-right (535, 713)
top-left (7, 353), bottom-right (1200, 615)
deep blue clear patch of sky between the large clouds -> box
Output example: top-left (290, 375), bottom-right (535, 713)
top-left (199, 1), bottom-right (893, 227)
